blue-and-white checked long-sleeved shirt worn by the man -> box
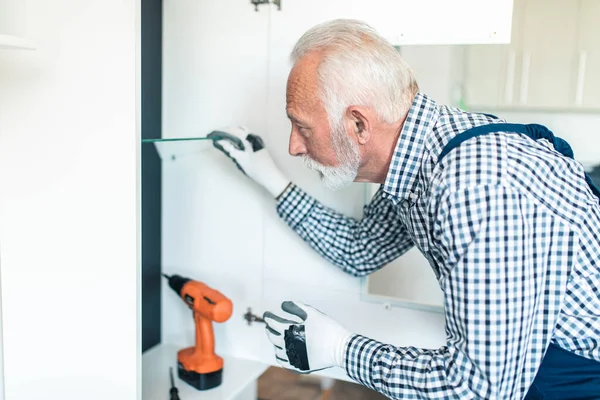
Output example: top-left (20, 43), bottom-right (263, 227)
top-left (277, 93), bottom-right (600, 399)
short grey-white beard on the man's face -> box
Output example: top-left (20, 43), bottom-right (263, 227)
top-left (302, 125), bottom-right (360, 190)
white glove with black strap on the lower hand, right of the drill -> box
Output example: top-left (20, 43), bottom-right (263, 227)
top-left (263, 301), bottom-right (352, 373)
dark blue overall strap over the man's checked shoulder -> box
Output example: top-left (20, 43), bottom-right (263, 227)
top-left (438, 123), bottom-right (600, 201)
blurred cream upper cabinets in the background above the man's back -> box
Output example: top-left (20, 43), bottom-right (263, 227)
top-left (463, 0), bottom-right (600, 110)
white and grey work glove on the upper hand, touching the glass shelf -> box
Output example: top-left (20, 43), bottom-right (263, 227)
top-left (207, 126), bottom-right (290, 197)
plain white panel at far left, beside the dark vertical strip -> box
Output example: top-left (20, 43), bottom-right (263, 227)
top-left (0, 0), bottom-right (139, 400)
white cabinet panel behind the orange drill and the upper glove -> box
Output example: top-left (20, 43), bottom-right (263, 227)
top-left (162, 0), bottom-right (273, 358)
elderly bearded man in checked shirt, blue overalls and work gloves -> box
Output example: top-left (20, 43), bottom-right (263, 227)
top-left (213, 20), bottom-right (600, 399)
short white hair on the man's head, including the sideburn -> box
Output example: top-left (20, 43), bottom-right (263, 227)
top-left (291, 19), bottom-right (419, 136)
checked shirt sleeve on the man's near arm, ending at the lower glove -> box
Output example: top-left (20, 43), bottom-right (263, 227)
top-left (346, 185), bottom-right (577, 399)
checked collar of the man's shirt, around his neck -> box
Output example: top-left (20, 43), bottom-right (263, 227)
top-left (383, 93), bottom-right (440, 204)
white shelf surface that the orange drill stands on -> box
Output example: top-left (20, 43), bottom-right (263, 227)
top-left (142, 344), bottom-right (269, 400)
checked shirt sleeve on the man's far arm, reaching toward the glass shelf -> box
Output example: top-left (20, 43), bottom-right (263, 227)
top-left (277, 184), bottom-right (413, 276)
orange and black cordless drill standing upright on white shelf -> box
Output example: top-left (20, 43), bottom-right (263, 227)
top-left (163, 274), bottom-right (233, 390)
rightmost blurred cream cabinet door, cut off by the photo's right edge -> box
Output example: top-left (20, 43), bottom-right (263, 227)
top-left (575, 0), bottom-right (600, 109)
